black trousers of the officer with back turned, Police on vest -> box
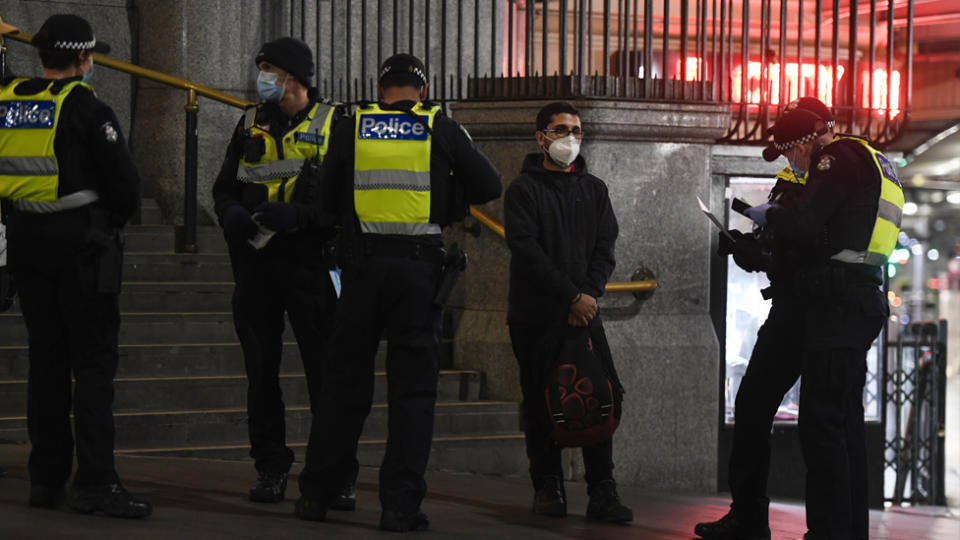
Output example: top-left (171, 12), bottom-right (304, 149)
top-left (300, 247), bottom-right (440, 514)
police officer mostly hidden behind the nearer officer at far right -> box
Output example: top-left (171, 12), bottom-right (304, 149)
top-left (694, 97), bottom-right (835, 540)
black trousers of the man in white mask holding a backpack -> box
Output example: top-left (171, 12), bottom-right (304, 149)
top-left (510, 323), bottom-right (613, 489)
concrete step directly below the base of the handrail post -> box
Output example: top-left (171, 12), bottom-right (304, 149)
top-left (123, 251), bottom-right (233, 282)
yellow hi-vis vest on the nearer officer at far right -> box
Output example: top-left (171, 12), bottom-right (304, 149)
top-left (830, 136), bottom-right (903, 266)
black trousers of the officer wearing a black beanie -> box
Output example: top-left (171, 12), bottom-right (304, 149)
top-left (231, 248), bottom-right (337, 473)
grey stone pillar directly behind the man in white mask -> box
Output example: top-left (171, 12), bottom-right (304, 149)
top-left (450, 100), bottom-right (729, 491)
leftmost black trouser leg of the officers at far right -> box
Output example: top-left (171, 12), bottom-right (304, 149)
top-left (727, 296), bottom-right (804, 532)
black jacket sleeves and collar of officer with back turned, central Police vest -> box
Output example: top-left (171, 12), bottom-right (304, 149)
top-left (321, 101), bottom-right (503, 245)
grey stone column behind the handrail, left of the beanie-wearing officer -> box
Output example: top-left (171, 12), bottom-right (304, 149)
top-left (132, 0), bottom-right (280, 224)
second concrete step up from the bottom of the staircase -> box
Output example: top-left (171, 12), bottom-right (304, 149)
top-left (0, 401), bottom-right (520, 452)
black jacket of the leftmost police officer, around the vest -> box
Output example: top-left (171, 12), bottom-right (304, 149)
top-left (0, 77), bottom-right (141, 249)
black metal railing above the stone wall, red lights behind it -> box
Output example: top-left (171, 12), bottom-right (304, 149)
top-left (289, 0), bottom-right (914, 144)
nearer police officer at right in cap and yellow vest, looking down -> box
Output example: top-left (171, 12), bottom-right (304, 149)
top-left (746, 103), bottom-right (903, 540)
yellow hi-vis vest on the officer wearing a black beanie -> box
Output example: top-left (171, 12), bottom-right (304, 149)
top-left (237, 103), bottom-right (334, 202)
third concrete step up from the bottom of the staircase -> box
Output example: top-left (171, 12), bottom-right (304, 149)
top-left (0, 370), bottom-right (481, 416)
